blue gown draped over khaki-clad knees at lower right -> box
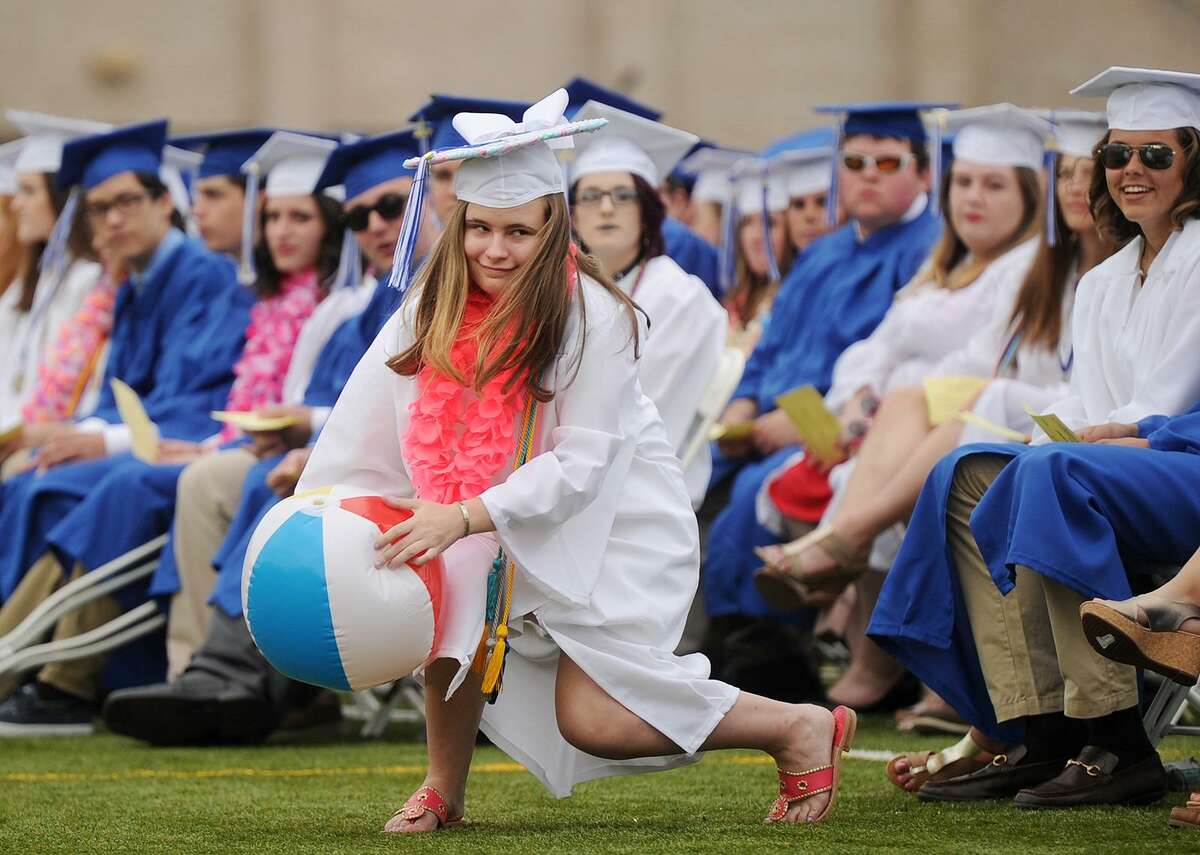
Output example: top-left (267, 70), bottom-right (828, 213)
top-left (868, 409), bottom-right (1200, 741)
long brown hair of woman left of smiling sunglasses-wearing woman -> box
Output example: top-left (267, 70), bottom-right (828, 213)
top-left (1009, 175), bottom-right (1116, 351)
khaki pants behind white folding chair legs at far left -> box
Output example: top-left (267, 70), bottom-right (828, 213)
top-left (0, 554), bottom-right (122, 700)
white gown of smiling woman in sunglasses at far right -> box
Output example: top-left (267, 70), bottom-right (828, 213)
top-left (1034, 220), bottom-right (1200, 434)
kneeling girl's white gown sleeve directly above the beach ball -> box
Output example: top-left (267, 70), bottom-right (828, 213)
top-left (296, 311), bottom-right (415, 496)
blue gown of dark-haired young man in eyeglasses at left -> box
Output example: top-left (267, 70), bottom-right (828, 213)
top-left (0, 232), bottom-right (247, 600)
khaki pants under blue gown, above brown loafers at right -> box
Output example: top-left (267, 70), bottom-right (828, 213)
top-left (946, 454), bottom-right (1138, 722)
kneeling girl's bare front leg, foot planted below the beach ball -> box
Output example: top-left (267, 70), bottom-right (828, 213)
top-left (384, 659), bottom-right (484, 832)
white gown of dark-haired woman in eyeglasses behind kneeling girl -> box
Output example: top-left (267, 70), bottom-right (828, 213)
top-left (618, 256), bottom-right (730, 507)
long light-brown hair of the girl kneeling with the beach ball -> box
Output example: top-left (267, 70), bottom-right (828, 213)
top-left (388, 193), bottom-right (640, 403)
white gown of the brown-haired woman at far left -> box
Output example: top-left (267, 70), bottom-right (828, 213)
top-left (0, 258), bottom-right (101, 426)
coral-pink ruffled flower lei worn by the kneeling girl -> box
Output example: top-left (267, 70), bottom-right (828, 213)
top-left (403, 285), bottom-right (526, 504)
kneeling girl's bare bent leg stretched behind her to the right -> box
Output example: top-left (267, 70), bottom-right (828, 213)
top-left (554, 656), bottom-right (834, 823)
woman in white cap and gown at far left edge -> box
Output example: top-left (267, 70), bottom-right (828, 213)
top-left (0, 110), bottom-right (109, 434)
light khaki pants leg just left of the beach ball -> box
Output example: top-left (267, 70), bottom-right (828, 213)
top-left (167, 448), bottom-right (257, 680)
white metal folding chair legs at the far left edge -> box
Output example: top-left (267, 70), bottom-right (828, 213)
top-left (0, 534), bottom-right (167, 676)
